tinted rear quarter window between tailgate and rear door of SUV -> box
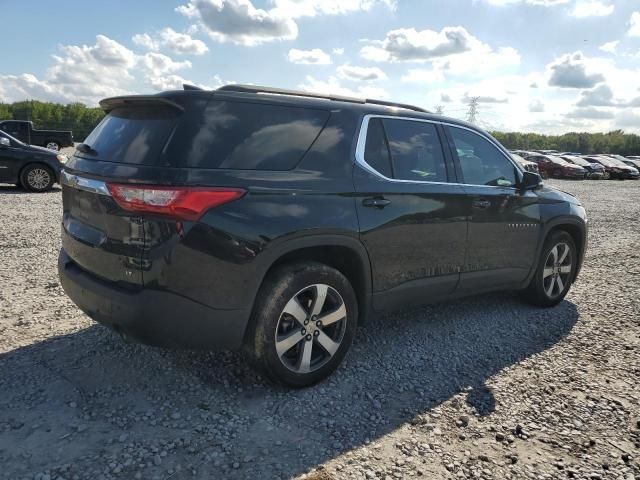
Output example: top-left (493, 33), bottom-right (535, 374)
top-left (187, 100), bottom-right (329, 170)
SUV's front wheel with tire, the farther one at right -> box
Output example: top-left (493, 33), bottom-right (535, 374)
top-left (521, 230), bottom-right (578, 307)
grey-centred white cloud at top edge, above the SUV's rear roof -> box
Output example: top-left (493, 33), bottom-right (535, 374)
top-left (176, 0), bottom-right (298, 46)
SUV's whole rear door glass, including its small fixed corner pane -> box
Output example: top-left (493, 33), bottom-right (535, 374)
top-left (365, 118), bottom-right (447, 182)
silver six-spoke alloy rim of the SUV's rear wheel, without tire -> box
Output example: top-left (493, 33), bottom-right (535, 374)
top-left (275, 284), bottom-right (347, 373)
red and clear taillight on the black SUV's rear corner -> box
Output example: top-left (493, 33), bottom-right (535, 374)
top-left (107, 183), bottom-right (246, 221)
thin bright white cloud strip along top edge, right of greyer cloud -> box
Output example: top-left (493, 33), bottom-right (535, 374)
top-left (273, 0), bottom-right (396, 18)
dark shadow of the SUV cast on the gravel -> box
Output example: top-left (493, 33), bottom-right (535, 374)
top-left (0, 294), bottom-right (579, 479)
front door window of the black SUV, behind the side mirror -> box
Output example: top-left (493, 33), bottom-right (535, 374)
top-left (449, 127), bottom-right (516, 187)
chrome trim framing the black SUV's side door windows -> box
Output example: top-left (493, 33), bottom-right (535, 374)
top-left (356, 114), bottom-right (522, 190)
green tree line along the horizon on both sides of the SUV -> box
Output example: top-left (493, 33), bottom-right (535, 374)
top-left (0, 100), bottom-right (640, 155)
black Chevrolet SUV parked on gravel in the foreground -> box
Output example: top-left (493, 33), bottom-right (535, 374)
top-left (58, 85), bottom-right (587, 387)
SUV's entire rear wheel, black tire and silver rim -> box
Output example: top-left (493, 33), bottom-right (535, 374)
top-left (248, 262), bottom-right (358, 388)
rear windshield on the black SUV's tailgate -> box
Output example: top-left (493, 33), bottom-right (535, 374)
top-left (76, 106), bottom-right (180, 165)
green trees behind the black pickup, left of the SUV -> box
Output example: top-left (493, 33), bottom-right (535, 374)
top-left (0, 100), bottom-right (104, 142)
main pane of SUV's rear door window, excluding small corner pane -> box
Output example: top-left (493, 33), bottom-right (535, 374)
top-left (384, 119), bottom-right (447, 182)
